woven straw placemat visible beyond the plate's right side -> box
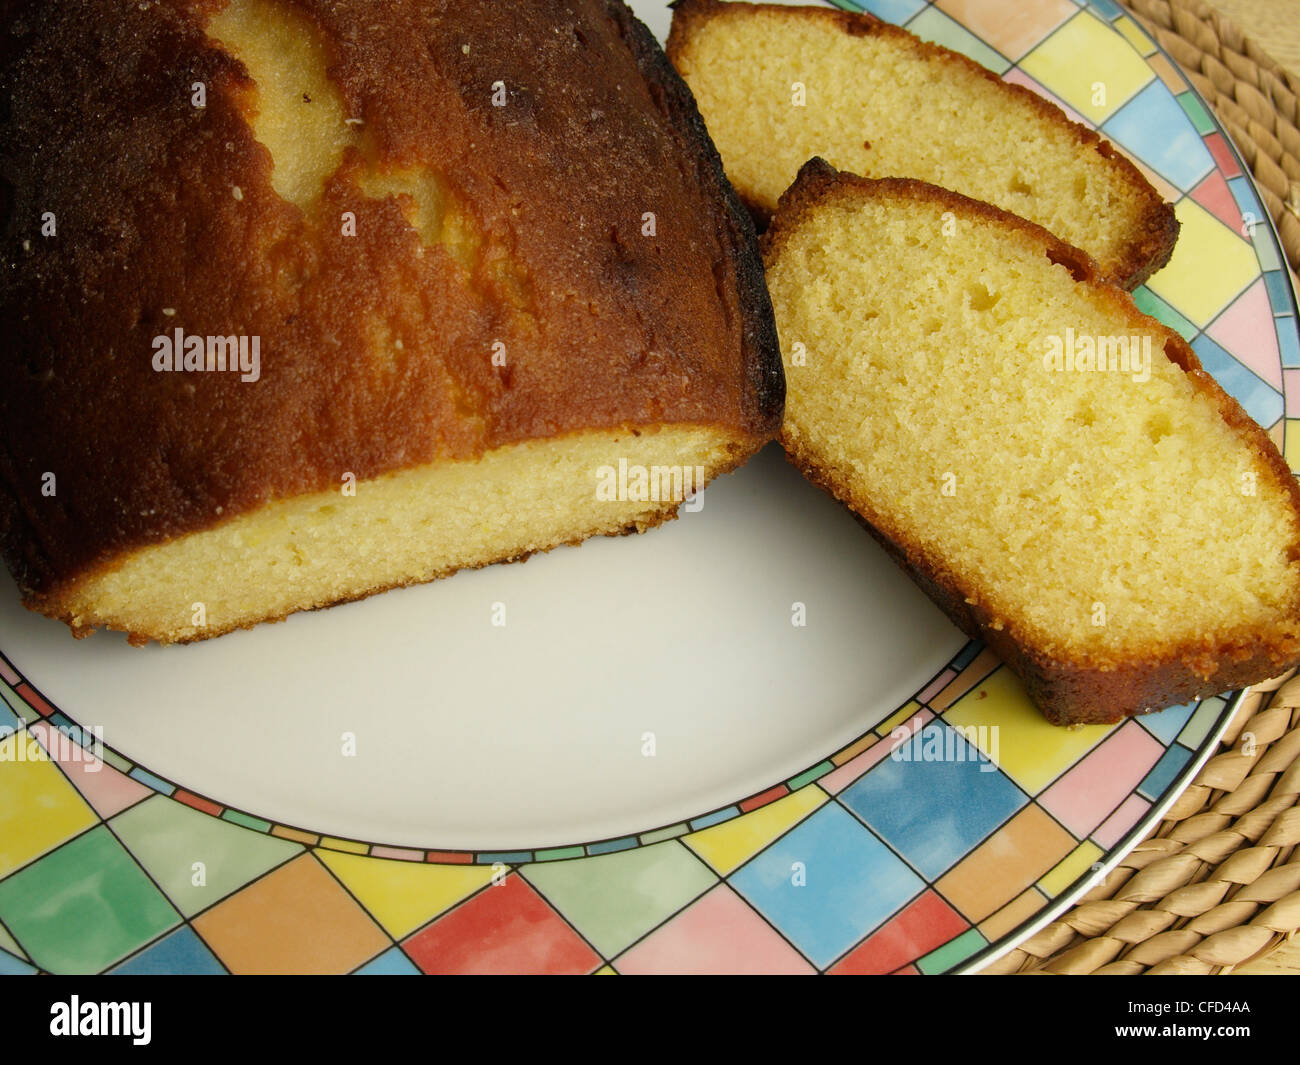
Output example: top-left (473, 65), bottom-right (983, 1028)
top-left (984, 0), bottom-right (1300, 975)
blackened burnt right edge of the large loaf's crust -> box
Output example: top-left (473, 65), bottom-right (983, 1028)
top-left (605, 0), bottom-right (785, 438)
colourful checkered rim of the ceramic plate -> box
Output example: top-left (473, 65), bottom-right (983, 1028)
top-left (0, 0), bottom-right (1300, 974)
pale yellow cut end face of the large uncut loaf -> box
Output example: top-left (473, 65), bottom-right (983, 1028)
top-left (27, 427), bottom-right (753, 644)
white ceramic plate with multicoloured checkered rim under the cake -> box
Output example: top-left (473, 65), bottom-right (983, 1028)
top-left (0, 0), bottom-right (1300, 973)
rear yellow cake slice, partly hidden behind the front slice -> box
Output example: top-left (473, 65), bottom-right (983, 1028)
top-left (668, 0), bottom-right (1178, 287)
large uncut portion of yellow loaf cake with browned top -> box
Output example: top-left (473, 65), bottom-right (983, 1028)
top-left (0, 0), bottom-right (784, 642)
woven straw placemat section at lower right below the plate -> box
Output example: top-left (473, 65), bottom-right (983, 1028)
top-left (984, 675), bottom-right (1300, 975)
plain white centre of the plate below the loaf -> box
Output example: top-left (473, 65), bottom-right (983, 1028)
top-left (0, 445), bottom-right (963, 850)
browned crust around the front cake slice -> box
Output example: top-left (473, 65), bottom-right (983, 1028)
top-left (762, 159), bottom-right (1300, 724)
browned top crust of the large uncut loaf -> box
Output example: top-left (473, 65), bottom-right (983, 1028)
top-left (0, 0), bottom-right (784, 611)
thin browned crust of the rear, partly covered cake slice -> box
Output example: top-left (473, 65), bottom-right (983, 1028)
top-left (667, 0), bottom-right (1178, 289)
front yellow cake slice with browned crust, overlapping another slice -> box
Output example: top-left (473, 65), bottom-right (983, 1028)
top-left (763, 160), bottom-right (1300, 724)
